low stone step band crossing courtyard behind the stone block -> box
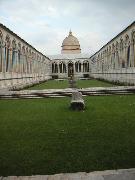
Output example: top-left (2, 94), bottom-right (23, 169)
top-left (0, 86), bottom-right (135, 99)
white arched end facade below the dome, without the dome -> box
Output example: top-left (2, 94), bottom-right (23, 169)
top-left (50, 54), bottom-right (90, 78)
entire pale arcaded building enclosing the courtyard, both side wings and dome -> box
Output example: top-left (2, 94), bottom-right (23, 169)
top-left (0, 22), bottom-right (135, 89)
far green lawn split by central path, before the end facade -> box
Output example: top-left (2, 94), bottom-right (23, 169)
top-left (29, 80), bottom-right (114, 89)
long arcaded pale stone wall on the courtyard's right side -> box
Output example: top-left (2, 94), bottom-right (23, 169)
top-left (90, 22), bottom-right (135, 84)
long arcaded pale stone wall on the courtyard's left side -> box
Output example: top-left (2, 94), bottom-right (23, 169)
top-left (0, 24), bottom-right (51, 88)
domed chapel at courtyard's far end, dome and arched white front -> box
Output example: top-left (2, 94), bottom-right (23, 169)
top-left (50, 30), bottom-right (90, 78)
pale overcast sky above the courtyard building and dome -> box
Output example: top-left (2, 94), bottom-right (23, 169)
top-left (0, 0), bottom-right (135, 55)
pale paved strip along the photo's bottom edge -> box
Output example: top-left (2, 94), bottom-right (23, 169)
top-left (0, 168), bottom-right (135, 180)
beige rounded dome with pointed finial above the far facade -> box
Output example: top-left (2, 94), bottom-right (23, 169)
top-left (61, 31), bottom-right (81, 54)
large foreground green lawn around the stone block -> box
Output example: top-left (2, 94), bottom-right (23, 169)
top-left (0, 95), bottom-right (135, 176)
